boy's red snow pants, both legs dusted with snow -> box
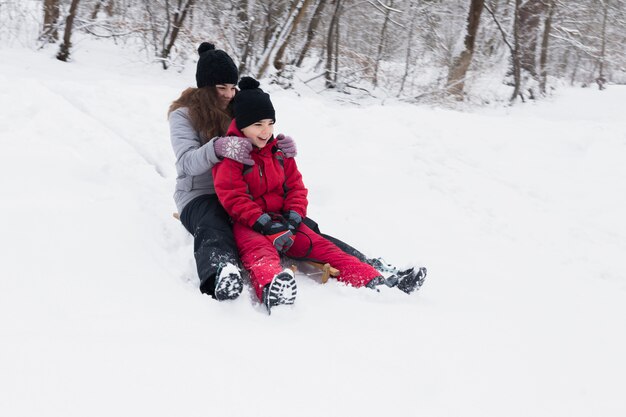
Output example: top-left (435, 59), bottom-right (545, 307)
top-left (233, 223), bottom-right (380, 300)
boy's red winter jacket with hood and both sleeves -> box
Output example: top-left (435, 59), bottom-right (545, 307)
top-left (213, 120), bottom-right (308, 227)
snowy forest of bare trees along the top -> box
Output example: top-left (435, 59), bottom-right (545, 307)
top-left (0, 0), bottom-right (626, 105)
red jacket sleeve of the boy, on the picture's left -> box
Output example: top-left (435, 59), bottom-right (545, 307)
top-left (213, 158), bottom-right (263, 227)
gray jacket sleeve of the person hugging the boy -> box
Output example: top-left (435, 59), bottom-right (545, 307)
top-left (169, 107), bottom-right (220, 176)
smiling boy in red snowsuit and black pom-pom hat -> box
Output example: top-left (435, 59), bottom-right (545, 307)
top-left (213, 77), bottom-right (383, 311)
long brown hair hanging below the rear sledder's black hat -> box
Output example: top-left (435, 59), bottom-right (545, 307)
top-left (167, 86), bottom-right (232, 145)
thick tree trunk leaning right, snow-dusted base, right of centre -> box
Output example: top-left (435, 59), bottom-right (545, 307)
top-left (447, 0), bottom-right (485, 100)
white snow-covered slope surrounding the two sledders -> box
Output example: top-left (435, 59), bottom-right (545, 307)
top-left (0, 43), bottom-right (626, 417)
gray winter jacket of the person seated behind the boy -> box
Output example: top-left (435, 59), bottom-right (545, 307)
top-left (169, 107), bottom-right (220, 213)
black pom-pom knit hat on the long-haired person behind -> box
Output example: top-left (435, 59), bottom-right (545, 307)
top-left (196, 42), bottom-right (239, 88)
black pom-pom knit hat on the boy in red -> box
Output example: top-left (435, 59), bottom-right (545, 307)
top-left (233, 77), bottom-right (276, 130)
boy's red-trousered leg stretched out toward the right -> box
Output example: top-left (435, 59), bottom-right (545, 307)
top-left (287, 224), bottom-right (380, 287)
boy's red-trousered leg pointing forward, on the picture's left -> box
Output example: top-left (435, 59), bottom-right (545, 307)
top-left (233, 223), bottom-right (283, 300)
